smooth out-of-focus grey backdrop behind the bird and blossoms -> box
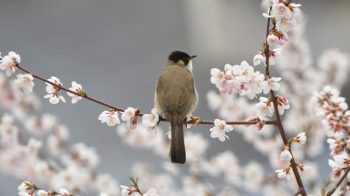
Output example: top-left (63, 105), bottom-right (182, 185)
top-left (0, 0), bottom-right (350, 195)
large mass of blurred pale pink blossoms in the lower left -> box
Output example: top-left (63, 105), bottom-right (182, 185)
top-left (0, 73), bottom-right (120, 196)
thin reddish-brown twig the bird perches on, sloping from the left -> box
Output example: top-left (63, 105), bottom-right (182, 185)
top-left (16, 64), bottom-right (277, 125)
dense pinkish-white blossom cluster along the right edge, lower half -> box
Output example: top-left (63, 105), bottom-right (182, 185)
top-left (314, 86), bottom-right (350, 194)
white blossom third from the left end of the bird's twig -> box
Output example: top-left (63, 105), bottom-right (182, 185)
top-left (44, 76), bottom-right (66, 104)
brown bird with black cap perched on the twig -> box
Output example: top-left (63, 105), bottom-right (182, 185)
top-left (154, 51), bottom-right (198, 164)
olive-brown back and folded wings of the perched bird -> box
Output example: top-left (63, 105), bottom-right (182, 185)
top-left (157, 66), bottom-right (196, 117)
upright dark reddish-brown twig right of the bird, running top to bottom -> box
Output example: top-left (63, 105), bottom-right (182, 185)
top-left (264, 3), bottom-right (307, 196)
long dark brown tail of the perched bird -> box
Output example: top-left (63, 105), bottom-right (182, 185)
top-left (169, 114), bottom-right (186, 164)
